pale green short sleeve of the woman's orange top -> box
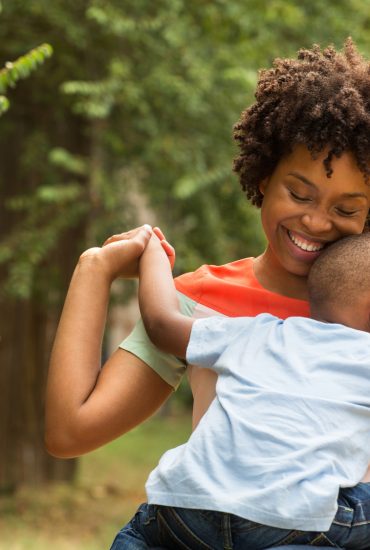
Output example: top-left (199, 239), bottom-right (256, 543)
top-left (119, 292), bottom-right (196, 389)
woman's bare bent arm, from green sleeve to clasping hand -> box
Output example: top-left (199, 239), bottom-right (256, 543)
top-left (45, 228), bottom-right (172, 457)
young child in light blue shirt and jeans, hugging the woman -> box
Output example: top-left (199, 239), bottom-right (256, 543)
top-left (113, 233), bottom-right (370, 550)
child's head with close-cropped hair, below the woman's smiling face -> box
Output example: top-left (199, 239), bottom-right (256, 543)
top-left (308, 233), bottom-right (370, 332)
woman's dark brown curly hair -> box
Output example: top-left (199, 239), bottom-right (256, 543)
top-left (234, 38), bottom-right (370, 206)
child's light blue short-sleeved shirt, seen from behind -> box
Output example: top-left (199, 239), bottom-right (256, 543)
top-left (146, 314), bottom-right (370, 531)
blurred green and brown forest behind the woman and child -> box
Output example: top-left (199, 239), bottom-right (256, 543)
top-left (0, 0), bottom-right (370, 548)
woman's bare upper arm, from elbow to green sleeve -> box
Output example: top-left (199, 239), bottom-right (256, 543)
top-left (46, 349), bottom-right (173, 457)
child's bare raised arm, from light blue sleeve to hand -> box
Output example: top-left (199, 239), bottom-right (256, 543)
top-left (139, 235), bottom-right (194, 358)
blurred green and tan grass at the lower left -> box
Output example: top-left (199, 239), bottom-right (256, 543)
top-left (0, 414), bottom-right (191, 550)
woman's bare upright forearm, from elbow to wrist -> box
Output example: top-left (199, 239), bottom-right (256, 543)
top-left (46, 255), bottom-right (110, 444)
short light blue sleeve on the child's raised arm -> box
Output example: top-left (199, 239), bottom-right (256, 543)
top-left (186, 316), bottom-right (255, 370)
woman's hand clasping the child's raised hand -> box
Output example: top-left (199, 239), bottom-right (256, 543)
top-left (80, 225), bottom-right (152, 281)
